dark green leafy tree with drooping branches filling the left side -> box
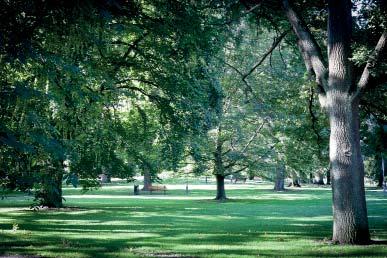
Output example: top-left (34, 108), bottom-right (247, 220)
top-left (1, 1), bottom-right (224, 207)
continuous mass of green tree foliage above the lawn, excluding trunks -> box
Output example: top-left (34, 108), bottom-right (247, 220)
top-left (0, 0), bottom-right (386, 208)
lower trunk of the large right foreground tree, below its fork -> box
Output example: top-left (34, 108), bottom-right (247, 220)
top-left (329, 94), bottom-right (370, 244)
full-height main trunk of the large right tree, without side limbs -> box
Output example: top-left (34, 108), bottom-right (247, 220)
top-left (327, 0), bottom-right (370, 244)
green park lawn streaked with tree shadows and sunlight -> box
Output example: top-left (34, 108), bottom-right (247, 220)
top-left (0, 184), bottom-right (387, 257)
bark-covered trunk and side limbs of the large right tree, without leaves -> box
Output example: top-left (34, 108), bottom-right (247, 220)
top-left (283, 0), bottom-right (374, 244)
